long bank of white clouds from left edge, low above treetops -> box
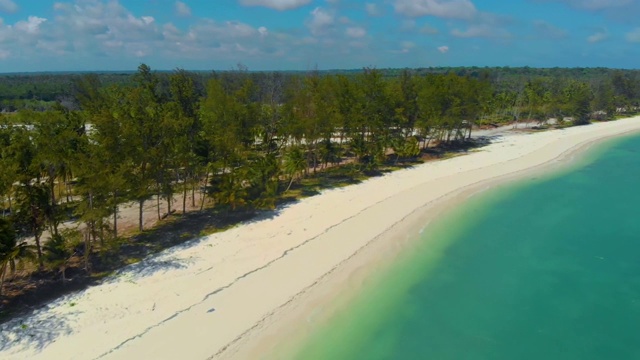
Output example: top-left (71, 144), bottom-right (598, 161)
top-left (0, 0), bottom-right (380, 71)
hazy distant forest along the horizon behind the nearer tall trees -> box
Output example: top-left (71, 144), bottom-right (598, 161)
top-left (0, 65), bottom-right (640, 112)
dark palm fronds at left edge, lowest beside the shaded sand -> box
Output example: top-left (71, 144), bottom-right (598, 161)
top-left (0, 218), bottom-right (36, 296)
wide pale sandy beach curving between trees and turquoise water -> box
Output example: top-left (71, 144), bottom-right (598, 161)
top-left (0, 118), bottom-right (640, 359)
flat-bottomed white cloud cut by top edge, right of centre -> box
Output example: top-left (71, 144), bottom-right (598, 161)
top-left (394, 0), bottom-right (478, 19)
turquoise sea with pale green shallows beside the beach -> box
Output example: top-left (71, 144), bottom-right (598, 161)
top-left (294, 137), bottom-right (640, 360)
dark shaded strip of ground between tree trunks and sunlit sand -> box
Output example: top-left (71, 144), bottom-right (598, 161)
top-left (0, 134), bottom-right (502, 344)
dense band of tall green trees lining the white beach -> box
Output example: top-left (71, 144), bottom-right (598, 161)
top-left (0, 64), bottom-right (640, 298)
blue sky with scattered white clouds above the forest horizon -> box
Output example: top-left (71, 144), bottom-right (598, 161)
top-left (0, 0), bottom-right (640, 72)
